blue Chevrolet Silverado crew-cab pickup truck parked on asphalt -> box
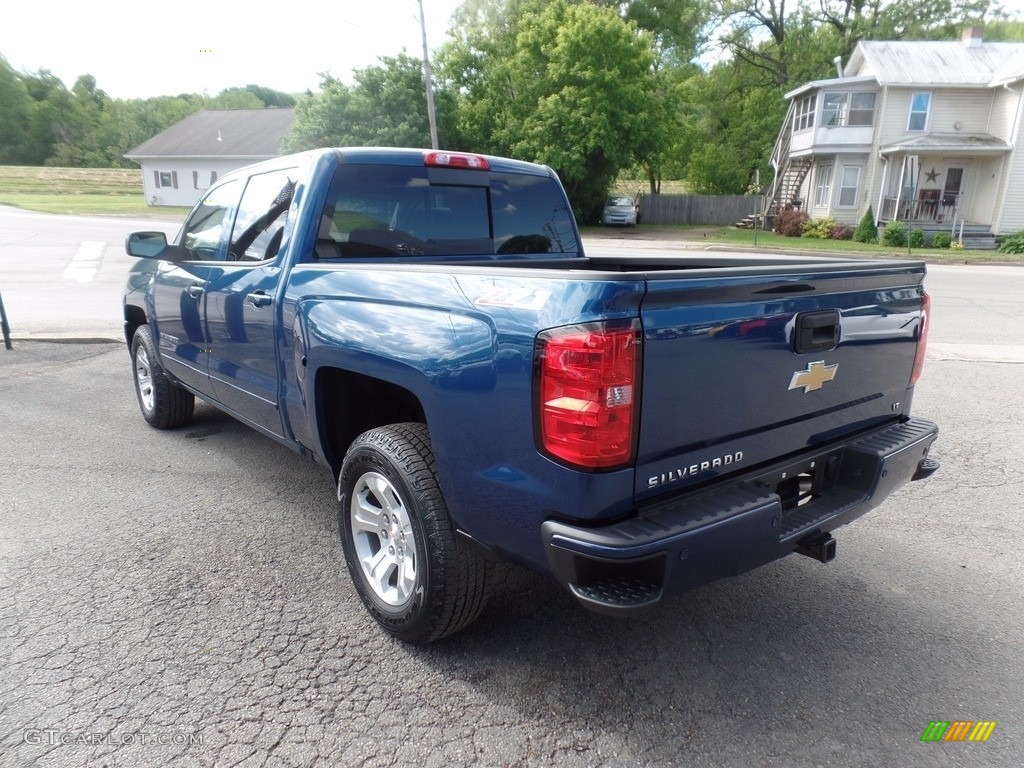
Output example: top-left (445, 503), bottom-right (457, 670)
top-left (124, 148), bottom-right (938, 643)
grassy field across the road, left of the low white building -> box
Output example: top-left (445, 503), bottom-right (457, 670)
top-left (0, 166), bottom-right (188, 217)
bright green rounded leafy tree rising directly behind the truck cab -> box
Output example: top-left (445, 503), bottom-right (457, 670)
top-left (437, 0), bottom-right (669, 219)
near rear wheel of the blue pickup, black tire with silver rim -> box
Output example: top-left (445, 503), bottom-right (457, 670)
top-left (338, 424), bottom-right (489, 643)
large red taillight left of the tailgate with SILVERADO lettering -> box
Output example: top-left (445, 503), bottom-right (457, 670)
top-left (538, 325), bottom-right (639, 469)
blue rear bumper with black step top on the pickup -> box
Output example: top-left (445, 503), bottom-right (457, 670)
top-left (542, 419), bottom-right (938, 614)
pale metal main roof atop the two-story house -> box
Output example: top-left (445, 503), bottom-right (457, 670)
top-left (844, 40), bottom-right (1024, 86)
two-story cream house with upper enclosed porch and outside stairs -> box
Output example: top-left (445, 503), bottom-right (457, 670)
top-left (764, 28), bottom-right (1024, 247)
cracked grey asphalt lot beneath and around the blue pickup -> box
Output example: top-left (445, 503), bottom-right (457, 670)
top-left (0, 342), bottom-right (1024, 768)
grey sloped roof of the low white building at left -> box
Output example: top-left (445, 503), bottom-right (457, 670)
top-left (125, 110), bottom-right (295, 160)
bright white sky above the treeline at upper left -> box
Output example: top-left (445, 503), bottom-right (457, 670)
top-left (0, 0), bottom-right (464, 98)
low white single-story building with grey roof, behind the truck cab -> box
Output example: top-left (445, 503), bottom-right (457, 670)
top-left (125, 110), bottom-right (295, 207)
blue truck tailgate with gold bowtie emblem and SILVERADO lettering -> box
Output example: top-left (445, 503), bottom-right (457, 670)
top-left (636, 262), bottom-right (925, 500)
